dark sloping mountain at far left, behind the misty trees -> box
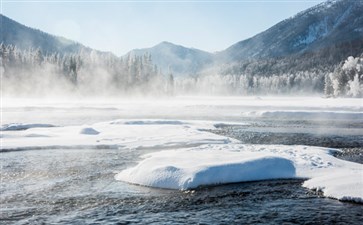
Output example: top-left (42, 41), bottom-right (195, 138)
top-left (0, 14), bottom-right (98, 54)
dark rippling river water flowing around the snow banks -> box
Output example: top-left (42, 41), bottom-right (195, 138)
top-left (0, 117), bottom-right (363, 224)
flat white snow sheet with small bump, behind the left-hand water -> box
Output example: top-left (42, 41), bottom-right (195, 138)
top-left (0, 119), bottom-right (235, 151)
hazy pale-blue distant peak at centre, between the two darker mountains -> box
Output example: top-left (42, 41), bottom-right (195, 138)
top-left (126, 42), bottom-right (214, 76)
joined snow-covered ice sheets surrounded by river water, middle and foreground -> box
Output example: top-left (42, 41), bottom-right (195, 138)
top-left (1, 119), bottom-right (363, 203)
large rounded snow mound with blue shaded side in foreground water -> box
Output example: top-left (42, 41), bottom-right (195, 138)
top-left (115, 149), bottom-right (295, 190)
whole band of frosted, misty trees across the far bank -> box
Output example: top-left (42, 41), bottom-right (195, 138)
top-left (0, 44), bottom-right (363, 97)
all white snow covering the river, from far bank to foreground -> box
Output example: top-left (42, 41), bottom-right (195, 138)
top-left (0, 97), bottom-right (363, 202)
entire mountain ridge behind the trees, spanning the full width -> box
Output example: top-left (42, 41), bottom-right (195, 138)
top-left (0, 0), bottom-right (363, 76)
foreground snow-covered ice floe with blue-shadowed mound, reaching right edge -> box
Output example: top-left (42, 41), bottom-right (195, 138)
top-left (115, 144), bottom-right (363, 203)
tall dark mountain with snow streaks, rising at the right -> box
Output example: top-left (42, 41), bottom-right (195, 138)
top-left (218, 0), bottom-right (363, 61)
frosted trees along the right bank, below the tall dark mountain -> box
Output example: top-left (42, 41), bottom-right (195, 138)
top-left (175, 54), bottom-right (363, 97)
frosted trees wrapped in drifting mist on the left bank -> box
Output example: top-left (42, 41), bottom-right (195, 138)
top-left (0, 44), bottom-right (173, 95)
